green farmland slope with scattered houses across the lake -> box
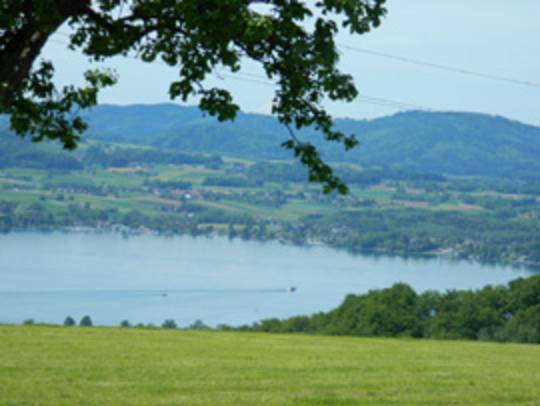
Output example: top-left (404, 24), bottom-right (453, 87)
top-left (0, 149), bottom-right (540, 266)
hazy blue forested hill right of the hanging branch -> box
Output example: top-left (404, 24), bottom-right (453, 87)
top-left (339, 112), bottom-right (540, 178)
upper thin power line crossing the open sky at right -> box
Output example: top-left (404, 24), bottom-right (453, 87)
top-left (338, 43), bottom-right (540, 87)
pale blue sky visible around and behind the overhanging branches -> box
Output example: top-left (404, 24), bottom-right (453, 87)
top-left (42, 0), bottom-right (540, 126)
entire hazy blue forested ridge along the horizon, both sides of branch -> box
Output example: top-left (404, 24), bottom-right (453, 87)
top-left (80, 104), bottom-right (540, 178)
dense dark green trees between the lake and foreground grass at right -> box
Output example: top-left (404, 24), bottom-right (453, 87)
top-left (244, 275), bottom-right (540, 344)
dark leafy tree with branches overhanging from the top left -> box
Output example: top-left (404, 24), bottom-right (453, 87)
top-left (0, 0), bottom-right (386, 193)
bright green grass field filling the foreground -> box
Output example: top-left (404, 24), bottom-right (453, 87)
top-left (0, 326), bottom-right (540, 405)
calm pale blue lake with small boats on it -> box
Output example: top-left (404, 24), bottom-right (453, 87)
top-left (0, 233), bottom-right (532, 326)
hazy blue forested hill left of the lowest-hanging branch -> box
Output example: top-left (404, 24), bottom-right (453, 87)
top-left (85, 104), bottom-right (291, 159)
